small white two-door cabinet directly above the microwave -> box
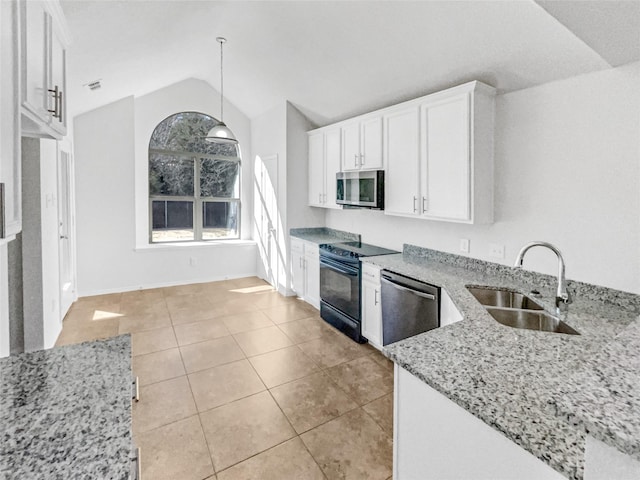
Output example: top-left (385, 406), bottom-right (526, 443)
top-left (342, 115), bottom-right (382, 172)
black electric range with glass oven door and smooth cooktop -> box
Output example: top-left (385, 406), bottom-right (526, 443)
top-left (320, 242), bottom-right (399, 343)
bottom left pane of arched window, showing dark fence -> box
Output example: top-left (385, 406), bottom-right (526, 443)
top-left (151, 200), bottom-right (194, 242)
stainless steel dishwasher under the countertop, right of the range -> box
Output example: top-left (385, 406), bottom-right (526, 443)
top-left (380, 270), bottom-right (440, 345)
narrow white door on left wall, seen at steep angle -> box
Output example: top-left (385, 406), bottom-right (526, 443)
top-left (58, 142), bottom-right (76, 318)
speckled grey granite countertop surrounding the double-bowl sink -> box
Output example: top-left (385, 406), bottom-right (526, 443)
top-left (363, 245), bottom-right (640, 479)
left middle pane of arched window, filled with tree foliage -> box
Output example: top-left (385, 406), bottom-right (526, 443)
top-left (149, 153), bottom-right (193, 197)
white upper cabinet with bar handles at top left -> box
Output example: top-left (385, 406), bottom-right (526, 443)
top-left (19, 0), bottom-right (68, 139)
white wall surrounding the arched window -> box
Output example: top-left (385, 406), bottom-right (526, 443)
top-left (74, 80), bottom-right (256, 296)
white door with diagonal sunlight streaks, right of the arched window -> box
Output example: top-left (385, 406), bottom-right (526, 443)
top-left (254, 155), bottom-right (281, 288)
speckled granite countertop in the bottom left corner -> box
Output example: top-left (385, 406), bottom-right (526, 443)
top-left (0, 335), bottom-right (132, 480)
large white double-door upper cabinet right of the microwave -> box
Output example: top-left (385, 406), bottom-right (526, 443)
top-left (384, 82), bottom-right (495, 224)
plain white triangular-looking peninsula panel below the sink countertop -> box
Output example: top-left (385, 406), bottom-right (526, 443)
top-left (393, 364), bottom-right (566, 480)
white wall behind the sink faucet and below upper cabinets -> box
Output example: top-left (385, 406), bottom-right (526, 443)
top-left (326, 63), bottom-right (640, 293)
